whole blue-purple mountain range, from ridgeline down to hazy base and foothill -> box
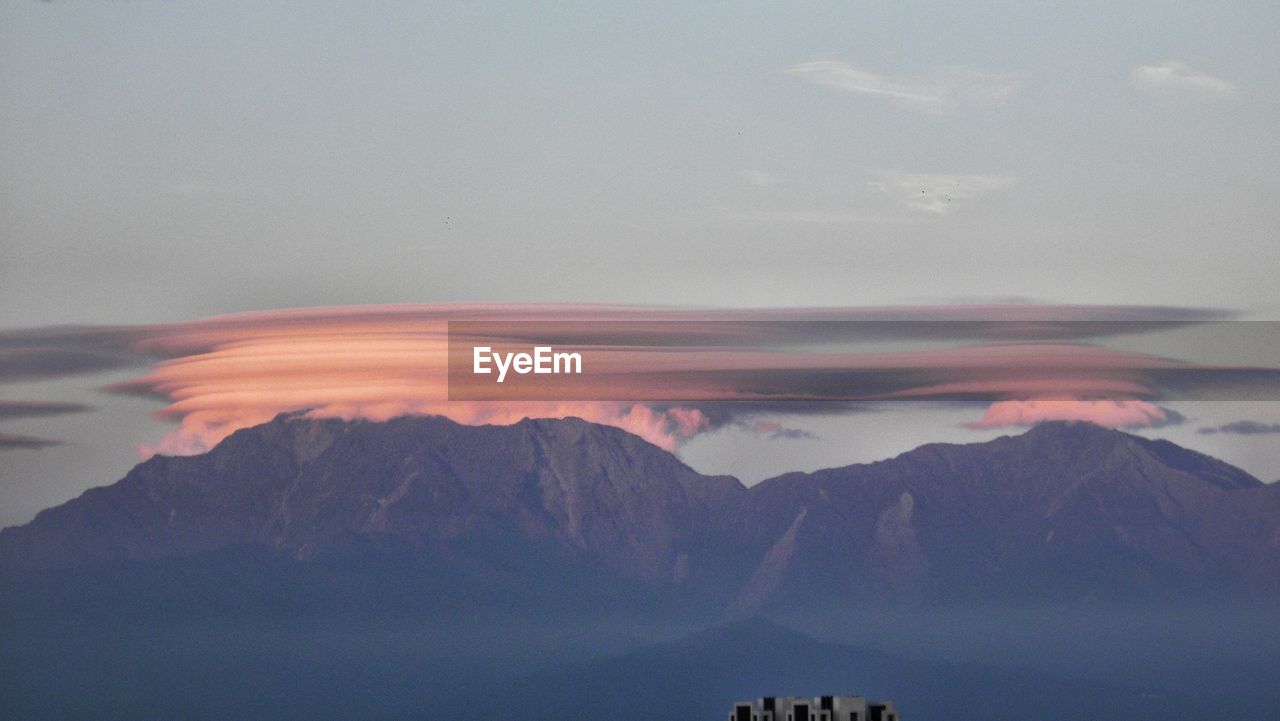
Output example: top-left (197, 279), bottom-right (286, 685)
top-left (0, 414), bottom-right (1280, 721)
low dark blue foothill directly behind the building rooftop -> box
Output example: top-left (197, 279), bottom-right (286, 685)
top-left (494, 619), bottom-right (1267, 721)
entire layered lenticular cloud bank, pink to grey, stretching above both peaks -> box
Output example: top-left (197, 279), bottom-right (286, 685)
top-left (0, 305), bottom-right (1280, 453)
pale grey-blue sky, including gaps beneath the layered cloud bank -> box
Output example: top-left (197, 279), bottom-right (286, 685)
top-left (0, 0), bottom-right (1280, 525)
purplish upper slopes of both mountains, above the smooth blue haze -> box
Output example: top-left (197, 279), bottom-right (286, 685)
top-left (0, 415), bottom-right (1280, 612)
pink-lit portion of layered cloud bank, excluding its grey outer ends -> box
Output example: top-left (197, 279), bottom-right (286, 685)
top-left (99, 304), bottom-right (1239, 455)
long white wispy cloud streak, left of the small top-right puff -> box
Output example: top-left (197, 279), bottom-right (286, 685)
top-left (787, 60), bottom-right (1023, 113)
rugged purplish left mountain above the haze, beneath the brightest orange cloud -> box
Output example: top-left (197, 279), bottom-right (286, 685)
top-left (0, 416), bottom-right (745, 601)
